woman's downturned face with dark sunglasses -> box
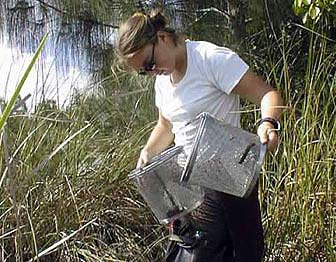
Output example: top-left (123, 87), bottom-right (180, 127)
top-left (130, 32), bottom-right (176, 75)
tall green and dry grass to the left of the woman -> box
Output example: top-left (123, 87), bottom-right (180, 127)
top-left (0, 64), bottom-right (163, 261)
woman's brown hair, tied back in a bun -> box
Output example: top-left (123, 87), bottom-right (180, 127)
top-left (116, 11), bottom-right (179, 62)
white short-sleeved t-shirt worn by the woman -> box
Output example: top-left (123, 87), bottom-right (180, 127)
top-left (155, 40), bottom-right (249, 150)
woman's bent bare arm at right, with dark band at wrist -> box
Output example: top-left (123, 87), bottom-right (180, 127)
top-left (232, 71), bottom-right (283, 151)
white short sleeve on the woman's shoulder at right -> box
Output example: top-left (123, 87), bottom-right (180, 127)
top-left (203, 45), bottom-right (249, 94)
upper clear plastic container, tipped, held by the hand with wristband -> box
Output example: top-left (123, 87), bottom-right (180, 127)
top-left (180, 113), bottom-right (266, 197)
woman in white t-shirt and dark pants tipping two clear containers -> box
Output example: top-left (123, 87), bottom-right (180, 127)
top-left (117, 12), bottom-right (282, 262)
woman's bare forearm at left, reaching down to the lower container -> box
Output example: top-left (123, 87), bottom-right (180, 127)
top-left (137, 111), bottom-right (174, 167)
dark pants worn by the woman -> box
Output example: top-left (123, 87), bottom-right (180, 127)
top-left (166, 186), bottom-right (264, 262)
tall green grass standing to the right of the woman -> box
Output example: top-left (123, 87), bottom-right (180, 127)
top-left (261, 26), bottom-right (336, 261)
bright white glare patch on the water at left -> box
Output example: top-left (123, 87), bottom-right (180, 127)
top-left (0, 42), bottom-right (88, 111)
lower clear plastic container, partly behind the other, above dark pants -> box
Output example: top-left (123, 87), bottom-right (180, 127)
top-left (129, 147), bottom-right (204, 223)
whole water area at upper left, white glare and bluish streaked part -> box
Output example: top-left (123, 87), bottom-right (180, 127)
top-left (0, 0), bottom-right (115, 111)
